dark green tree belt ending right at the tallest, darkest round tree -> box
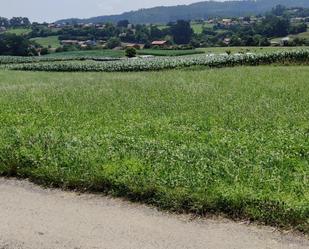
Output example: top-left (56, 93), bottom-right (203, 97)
top-left (27, 20), bottom-right (194, 47)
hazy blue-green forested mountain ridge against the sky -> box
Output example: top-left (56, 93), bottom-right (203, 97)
top-left (57, 0), bottom-right (309, 24)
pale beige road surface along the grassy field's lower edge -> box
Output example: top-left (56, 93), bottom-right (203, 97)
top-left (0, 178), bottom-right (309, 249)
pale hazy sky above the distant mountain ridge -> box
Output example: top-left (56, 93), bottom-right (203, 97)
top-left (0, 0), bottom-right (201, 22)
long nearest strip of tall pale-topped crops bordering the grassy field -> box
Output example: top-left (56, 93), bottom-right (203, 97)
top-left (7, 50), bottom-right (309, 72)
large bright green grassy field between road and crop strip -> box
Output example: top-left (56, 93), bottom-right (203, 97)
top-left (0, 66), bottom-right (309, 232)
